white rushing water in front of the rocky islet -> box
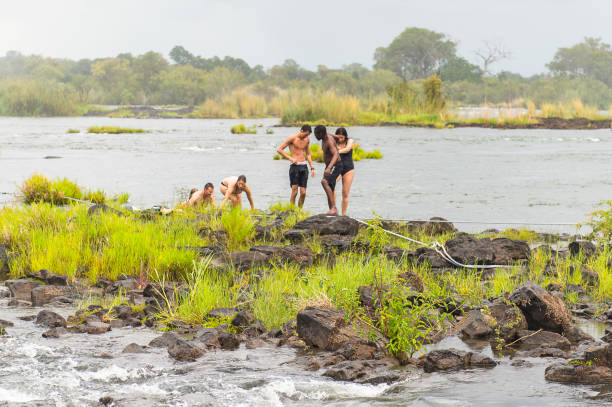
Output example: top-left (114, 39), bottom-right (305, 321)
top-left (0, 300), bottom-right (612, 407)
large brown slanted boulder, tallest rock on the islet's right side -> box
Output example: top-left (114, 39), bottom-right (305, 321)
top-left (510, 281), bottom-right (573, 333)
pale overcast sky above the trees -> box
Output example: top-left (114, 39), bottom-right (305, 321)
top-left (0, 0), bottom-right (612, 75)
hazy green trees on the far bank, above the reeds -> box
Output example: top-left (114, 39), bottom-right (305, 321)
top-left (0, 28), bottom-right (612, 115)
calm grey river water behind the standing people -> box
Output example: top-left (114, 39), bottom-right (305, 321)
top-left (0, 118), bottom-right (612, 232)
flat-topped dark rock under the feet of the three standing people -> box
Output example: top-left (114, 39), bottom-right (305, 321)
top-left (285, 214), bottom-right (359, 241)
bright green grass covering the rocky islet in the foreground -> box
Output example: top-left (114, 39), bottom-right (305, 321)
top-left (0, 175), bottom-right (612, 358)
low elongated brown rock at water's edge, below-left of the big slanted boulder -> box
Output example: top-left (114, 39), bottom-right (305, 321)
top-left (419, 348), bottom-right (497, 373)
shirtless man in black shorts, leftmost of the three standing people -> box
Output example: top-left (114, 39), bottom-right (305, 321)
top-left (276, 124), bottom-right (315, 208)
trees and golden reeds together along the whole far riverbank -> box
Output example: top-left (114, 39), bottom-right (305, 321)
top-left (0, 27), bottom-right (612, 129)
